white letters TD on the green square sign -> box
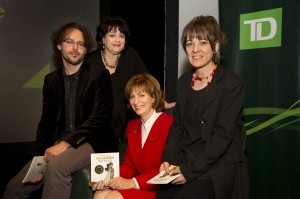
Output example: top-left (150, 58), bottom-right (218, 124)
top-left (244, 17), bottom-right (277, 41)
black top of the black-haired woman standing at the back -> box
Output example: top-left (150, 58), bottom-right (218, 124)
top-left (86, 46), bottom-right (149, 137)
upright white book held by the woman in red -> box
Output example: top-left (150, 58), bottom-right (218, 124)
top-left (91, 152), bottom-right (120, 182)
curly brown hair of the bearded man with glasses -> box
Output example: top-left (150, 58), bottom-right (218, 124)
top-left (51, 22), bottom-right (95, 54)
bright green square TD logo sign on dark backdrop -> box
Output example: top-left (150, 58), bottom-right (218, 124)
top-left (240, 8), bottom-right (282, 50)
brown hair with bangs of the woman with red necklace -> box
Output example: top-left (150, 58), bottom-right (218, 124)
top-left (181, 15), bottom-right (227, 64)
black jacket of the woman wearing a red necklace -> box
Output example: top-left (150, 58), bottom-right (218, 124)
top-left (161, 65), bottom-right (249, 199)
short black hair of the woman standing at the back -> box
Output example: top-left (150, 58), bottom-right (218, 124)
top-left (96, 16), bottom-right (130, 49)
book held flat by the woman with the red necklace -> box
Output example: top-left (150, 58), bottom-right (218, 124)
top-left (147, 165), bottom-right (180, 184)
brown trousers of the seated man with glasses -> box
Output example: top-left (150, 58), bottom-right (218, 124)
top-left (2, 143), bottom-right (94, 199)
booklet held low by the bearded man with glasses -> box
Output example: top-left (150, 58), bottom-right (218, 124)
top-left (22, 156), bottom-right (47, 183)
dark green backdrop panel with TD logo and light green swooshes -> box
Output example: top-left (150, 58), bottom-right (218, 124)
top-left (219, 0), bottom-right (300, 199)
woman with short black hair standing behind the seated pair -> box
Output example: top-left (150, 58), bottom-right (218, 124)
top-left (86, 17), bottom-right (149, 138)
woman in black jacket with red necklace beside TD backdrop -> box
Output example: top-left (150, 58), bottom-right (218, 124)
top-left (156, 16), bottom-right (249, 199)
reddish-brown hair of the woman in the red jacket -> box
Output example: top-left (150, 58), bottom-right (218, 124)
top-left (125, 74), bottom-right (165, 112)
